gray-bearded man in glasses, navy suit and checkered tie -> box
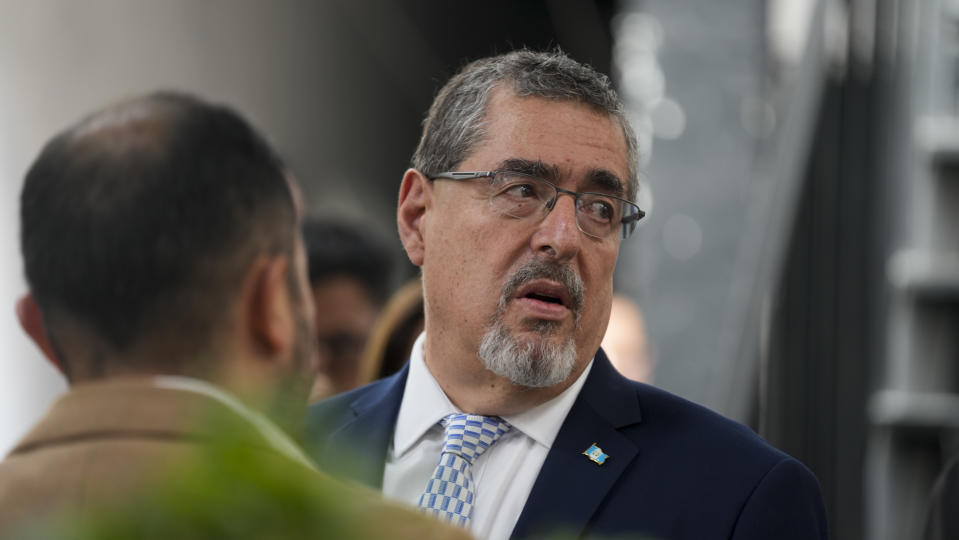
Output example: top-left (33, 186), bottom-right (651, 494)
top-left (311, 51), bottom-right (826, 539)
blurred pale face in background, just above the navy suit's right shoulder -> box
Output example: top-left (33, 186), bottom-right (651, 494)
top-left (601, 294), bottom-right (653, 383)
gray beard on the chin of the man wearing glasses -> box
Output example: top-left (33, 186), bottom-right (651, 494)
top-left (479, 317), bottom-right (576, 388)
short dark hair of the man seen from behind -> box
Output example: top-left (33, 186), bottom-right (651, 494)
top-left (20, 92), bottom-right (296, 362)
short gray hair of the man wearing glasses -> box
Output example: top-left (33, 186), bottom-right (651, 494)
top-left (412, 49), bottom-right (639, 200)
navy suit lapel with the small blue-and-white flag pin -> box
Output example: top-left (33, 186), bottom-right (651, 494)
top-left (512, 350), bottom-right (641, 538)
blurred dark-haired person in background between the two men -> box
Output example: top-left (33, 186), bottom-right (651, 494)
top-left (303, 218), bottom-right (392, 400)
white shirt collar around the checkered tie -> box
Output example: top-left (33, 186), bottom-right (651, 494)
top-left (393, 332), bottom-right (593, 456)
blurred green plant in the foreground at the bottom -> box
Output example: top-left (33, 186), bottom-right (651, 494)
top-left (12, 408), bottom-right (420, 540)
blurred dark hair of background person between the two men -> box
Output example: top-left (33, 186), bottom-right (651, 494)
top-left (303, 217), bottom-right (393, 304)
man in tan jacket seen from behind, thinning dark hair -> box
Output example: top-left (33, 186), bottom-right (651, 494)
top-left (0, 92), bottom-right (460, 537)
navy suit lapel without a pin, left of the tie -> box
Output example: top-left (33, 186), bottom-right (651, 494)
top-left (323, 362), bottom-right (409, 489)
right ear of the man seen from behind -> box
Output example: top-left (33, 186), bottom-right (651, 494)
top-left (240, 255), bottom-right (296, 356)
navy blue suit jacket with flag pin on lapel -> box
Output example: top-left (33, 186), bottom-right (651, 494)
top-left (309, 351), bottom-right (827, 540)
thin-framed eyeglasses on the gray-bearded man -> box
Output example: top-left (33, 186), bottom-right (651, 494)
top-left (430, 171), bottom-right (646, 239)
